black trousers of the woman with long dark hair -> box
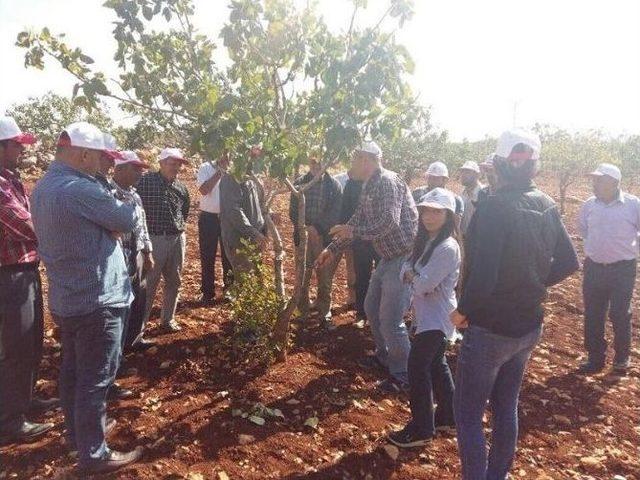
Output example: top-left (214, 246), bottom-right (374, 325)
top-left (407, 330), bottom-right (454, 436)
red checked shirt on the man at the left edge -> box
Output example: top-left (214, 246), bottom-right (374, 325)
top-left (0, 169), bottom-right (39, 267)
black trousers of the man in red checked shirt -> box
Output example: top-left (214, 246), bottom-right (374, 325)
top-left (0, 263), bottom-right (44, 432)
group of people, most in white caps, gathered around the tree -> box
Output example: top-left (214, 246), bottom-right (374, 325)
top-left (0, 111), bottom-right (640, 480)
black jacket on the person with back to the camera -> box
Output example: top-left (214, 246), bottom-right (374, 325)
top-left (458, 184), bottom-right (579, 337)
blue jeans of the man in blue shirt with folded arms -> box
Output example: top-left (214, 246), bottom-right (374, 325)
top-left (54, 308), bottom-right (128, 466)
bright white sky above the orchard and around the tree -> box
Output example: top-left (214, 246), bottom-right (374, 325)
top-left (0, 0), bottom-right (640, 140)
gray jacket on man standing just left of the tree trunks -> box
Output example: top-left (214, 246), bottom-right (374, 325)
top-left (220, 175), bottom-right (264, 252)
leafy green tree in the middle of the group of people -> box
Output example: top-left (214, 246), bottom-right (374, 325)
top-left (17, 0), bottom-right (416, 358)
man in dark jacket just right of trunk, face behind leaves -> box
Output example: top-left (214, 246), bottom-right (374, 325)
top-left (289, 157), bottom-right (342, 321)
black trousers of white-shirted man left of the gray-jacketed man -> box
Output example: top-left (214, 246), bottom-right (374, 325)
top-left (198, 211), bottom-right (232, 298)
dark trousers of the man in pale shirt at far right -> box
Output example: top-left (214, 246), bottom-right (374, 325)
top-left (582, 258), bottom-right (636, 363)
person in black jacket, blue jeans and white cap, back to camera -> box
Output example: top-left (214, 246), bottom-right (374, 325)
top-left (451, 129), bottom-right (579, 480)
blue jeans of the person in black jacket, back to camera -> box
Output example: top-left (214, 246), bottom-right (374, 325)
top-left (454, 325), bottom-right (542, 480)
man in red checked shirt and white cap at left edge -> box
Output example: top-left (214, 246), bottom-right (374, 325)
top-left (0, 117), bottom-right (58, 444)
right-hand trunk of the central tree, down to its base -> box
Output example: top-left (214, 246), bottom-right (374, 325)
top-left (273, 193), bottom-right (307, 362)
